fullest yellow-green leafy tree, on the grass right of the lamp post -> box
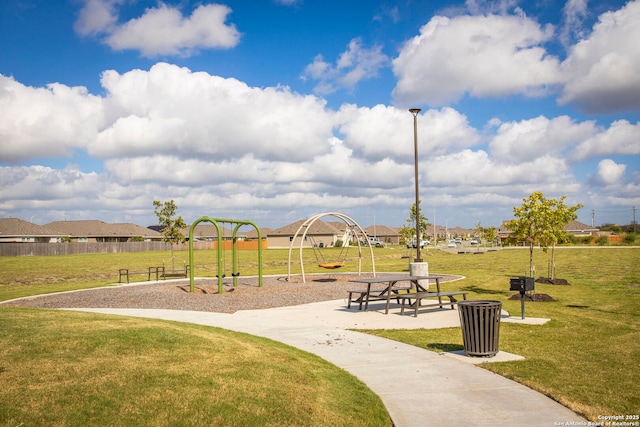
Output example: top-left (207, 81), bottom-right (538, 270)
top-left (506, 191), bottom-right (582, 279)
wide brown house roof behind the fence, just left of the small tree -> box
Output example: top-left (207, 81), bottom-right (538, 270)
top-left (45, 220), bottom-right (162, 238)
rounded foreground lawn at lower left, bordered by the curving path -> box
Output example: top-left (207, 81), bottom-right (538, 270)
top-left (0, 307), bottom-right (390, 427)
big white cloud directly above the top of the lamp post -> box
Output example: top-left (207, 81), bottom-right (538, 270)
top-left (393, 15), bottom-right (560, 105)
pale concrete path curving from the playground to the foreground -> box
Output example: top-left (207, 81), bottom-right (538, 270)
top-left (67, 300), bottom-right (586, 427)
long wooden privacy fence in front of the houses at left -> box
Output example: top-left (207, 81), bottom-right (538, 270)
top-left (0, 242), bottom-right (215, 256)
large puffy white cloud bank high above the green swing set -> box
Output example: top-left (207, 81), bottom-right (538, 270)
top-left (94, 63), bottom-right (334, 160)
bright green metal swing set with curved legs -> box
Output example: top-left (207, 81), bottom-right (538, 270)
top-left (189, 216), bottom-right (262, 294)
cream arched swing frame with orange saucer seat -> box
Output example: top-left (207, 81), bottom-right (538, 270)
top-left (287, 212), bottom-right (376, 283)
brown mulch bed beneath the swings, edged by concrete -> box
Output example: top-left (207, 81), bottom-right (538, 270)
top-left (5, 273), bottom-right (454, 313)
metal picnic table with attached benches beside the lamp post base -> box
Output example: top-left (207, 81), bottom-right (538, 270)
top-left (347, 275), bottom-right (467, 317)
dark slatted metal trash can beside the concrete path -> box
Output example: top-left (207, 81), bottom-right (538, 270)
top-left (458, 300), bottom-right (502, 357)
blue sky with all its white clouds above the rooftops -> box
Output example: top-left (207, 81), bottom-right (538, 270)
top-left (0, 0), bottom-right (640, 228)
